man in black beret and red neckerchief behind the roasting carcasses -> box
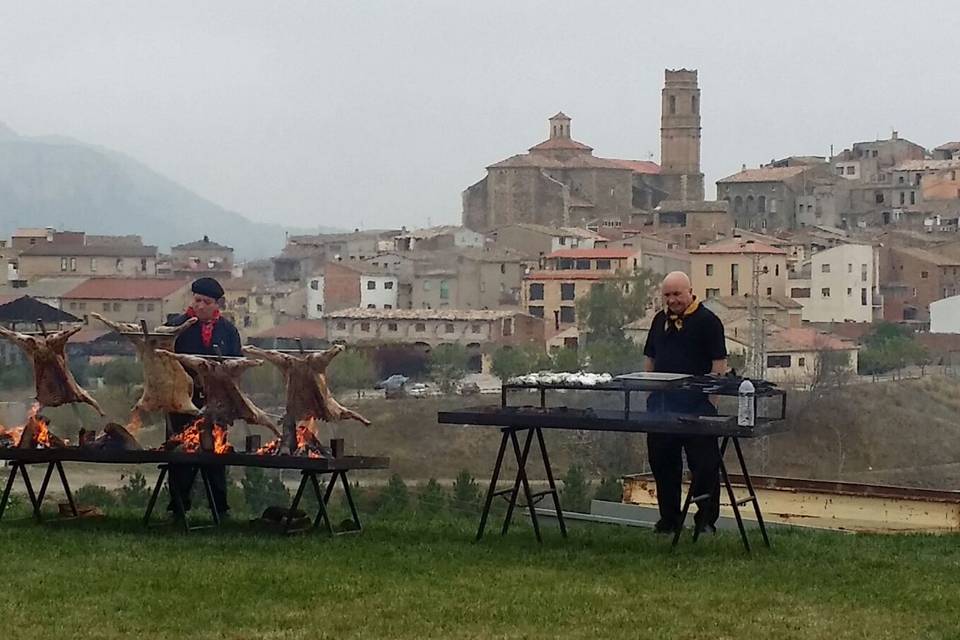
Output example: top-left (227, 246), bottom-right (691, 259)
top-left (167, 278), bottom-right (243, 516)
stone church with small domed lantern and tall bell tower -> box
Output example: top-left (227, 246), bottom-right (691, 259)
top-left (463, 69), bottom-right (703, 232)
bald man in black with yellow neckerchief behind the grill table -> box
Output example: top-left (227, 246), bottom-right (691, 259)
top-left (643, 271), bottom-right (727, 532)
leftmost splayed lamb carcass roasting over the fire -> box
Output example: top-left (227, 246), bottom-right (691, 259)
top-left (0, 327), bottom-right (105, 416)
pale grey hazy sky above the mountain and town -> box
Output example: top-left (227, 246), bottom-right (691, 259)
top-left (0, 0), bottom-right (960, 227)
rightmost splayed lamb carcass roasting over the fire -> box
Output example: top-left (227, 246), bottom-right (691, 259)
top-left (243, 345), bottom-right (370, 426)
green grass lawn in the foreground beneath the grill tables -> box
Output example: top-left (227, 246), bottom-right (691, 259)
top-left (0, 515), bottom-right (960, 640)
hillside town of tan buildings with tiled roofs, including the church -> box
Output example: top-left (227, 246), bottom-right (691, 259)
top-left (0, 69), bottom-right (960, 384)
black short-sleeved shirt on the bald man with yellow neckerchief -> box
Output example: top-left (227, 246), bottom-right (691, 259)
top-left (643, 304), bottom-right (727, 415)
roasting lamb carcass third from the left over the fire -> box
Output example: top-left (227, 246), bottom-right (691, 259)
top-left (157, 349), bottom-right (280, 436)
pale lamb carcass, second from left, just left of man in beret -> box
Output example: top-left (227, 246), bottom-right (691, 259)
top-left (90, 313), bottom-right (200, 418)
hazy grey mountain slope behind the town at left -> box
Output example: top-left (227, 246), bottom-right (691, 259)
top-left (0, 123), bottom-right (338, 258)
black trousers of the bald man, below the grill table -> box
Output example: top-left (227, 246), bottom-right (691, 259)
top-left (647, 433), bottom-right (720, 527)
